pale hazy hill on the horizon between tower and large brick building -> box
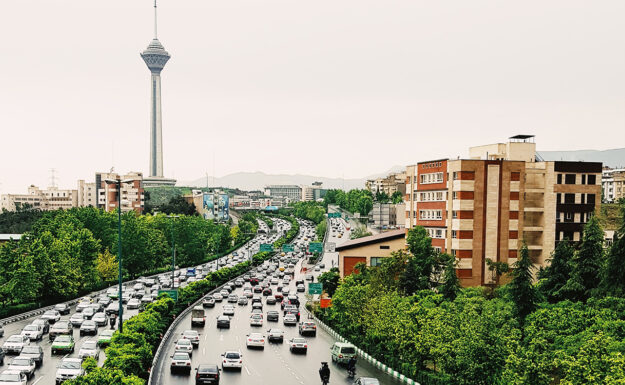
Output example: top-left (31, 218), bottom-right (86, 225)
top-left (178, 166), bottom-right (405, 191)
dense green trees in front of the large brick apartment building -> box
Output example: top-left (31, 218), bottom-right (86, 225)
top-left (316, 201), bottom-right (625, 385)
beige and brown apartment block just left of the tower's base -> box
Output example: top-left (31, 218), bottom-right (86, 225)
top-left (96, 172), bottom-right (145, 214)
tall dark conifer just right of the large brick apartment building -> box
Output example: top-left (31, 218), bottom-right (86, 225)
top-left (560, 216), bottom-right (603, 301)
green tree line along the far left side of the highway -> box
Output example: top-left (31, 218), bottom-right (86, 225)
top-left (0, 207), bottom-right (257, 310)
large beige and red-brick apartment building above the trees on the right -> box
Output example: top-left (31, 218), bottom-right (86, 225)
top-left (406, 135), bottom-right (601, 286)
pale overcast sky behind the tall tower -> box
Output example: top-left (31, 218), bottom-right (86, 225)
top-left (0, 0), bottom-right (625, 193)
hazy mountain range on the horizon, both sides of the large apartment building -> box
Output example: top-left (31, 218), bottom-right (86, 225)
top-left (183, 148), bottom-right (625, 191)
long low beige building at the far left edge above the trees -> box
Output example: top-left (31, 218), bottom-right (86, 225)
top-left (0, 185), bottom-right (78, 211)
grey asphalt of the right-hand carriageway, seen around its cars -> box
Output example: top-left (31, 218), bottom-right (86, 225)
top-left (153, 219), bottom-right (397, 385)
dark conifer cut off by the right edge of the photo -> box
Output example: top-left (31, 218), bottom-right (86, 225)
top-left (600, 202), bottom-right (625, 297)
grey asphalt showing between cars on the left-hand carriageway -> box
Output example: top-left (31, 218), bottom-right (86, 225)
top-left (0, 220), bottom-right (282, 385)
